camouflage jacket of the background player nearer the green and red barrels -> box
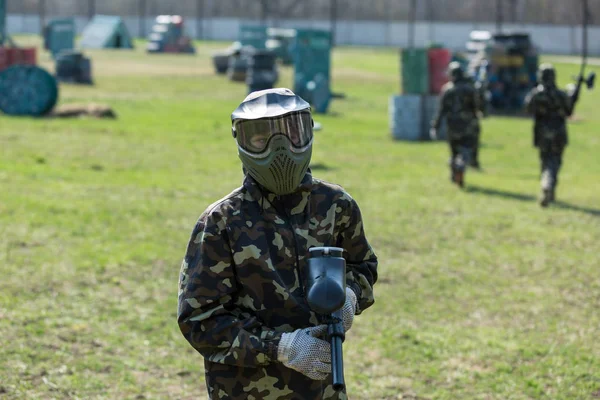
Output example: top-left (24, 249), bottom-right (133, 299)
top-left (432, 80), bottom-right (481, 140)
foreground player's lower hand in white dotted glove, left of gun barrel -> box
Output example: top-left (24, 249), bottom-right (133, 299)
top-left (277, 325), bottom-right (331, 381)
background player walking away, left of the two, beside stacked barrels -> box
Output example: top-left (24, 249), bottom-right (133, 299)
top-left (431, 61), bottom-right (480, 187)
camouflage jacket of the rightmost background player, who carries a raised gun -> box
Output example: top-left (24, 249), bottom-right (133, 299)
top-left (525, 85), bottom-right (573, 149)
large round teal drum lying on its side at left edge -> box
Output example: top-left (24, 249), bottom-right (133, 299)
top-left (0, 65), bottom-right (58, 116)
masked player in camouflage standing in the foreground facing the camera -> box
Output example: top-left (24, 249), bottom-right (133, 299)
top-left (178, 89), bottom-right (377, 400)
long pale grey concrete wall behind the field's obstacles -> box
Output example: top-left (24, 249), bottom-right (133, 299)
top-left (7, 14), bottom-right (600, 56)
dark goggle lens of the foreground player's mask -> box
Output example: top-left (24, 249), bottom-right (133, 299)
top-left (235, 112), bottom-right (313, 153)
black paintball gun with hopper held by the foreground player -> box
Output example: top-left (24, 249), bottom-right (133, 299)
top-left (306, 247), bottom-right (346, 391)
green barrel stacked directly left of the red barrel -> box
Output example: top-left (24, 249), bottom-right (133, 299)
top-left (402, 49), bottom-right (429, 94)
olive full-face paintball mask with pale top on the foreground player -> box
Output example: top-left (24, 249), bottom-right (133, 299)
top-left (231, 89), bottom-right (313, 195)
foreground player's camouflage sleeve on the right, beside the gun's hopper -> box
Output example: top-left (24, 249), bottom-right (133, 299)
top-left (337, 195), bottom-right (377, 314)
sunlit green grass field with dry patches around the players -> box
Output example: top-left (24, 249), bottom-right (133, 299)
top-left (0, 38), bottom-right (600, 400)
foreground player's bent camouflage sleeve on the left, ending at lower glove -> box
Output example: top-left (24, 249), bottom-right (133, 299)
top-left (177, 214), bottom-right (281, 367)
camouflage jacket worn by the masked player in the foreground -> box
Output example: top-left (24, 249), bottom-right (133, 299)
top-left (178, 171), bottom-right (377, 399)
